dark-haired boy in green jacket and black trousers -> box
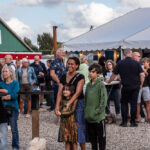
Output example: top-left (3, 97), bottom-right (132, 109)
top-left (84, 63), bottom-right (107, 150)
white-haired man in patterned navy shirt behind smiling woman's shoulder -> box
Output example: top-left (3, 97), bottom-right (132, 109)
top-left (50, 48), bottom-right (66, 110)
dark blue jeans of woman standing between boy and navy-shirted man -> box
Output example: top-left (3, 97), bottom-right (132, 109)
top-left (106, 88), bottom-right (120, 114)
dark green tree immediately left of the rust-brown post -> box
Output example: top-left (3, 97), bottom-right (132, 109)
top-left (37, 33), bottom-right (53, 53)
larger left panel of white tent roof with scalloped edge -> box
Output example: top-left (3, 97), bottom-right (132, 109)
top-left (63, 8), bottom-right (150, 51)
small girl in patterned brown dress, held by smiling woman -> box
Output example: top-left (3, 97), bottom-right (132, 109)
top-left (59, 84), bottom-right (77, 150)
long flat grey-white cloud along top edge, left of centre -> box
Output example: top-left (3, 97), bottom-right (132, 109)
top-left (15, 0), bottom-right (80, 6)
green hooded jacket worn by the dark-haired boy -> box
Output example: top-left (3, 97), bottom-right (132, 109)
top-left (84, 78), bottom-right (107, 123)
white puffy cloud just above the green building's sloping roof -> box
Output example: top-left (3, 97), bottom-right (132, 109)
top-left (6, 18), bottom-right (33, 38)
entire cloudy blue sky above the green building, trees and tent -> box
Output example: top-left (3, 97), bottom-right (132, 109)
top-left (0, 0), bottom-right (150, 44)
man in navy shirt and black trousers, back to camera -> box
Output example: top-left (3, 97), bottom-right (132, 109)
top-left (108, 49), bottom-right (144, 127)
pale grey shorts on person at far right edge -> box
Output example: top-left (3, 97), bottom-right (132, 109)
top-left (137, 86), bottom-right (150, 104)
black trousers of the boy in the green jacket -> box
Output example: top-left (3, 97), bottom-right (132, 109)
top-left (87, 120), bottom-right (106, 150)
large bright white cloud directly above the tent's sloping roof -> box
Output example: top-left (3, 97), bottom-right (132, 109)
top-left (58, 2), bottom-right (128, 41)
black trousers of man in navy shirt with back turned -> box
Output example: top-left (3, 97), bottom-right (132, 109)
top-left (121, 87), bottom-right (139, 123)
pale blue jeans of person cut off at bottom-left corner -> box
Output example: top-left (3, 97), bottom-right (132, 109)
top-left (0, 123), bottom-right (8, 150)
